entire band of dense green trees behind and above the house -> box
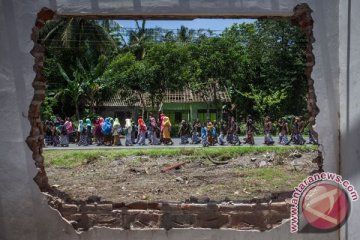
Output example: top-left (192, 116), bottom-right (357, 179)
top-left (41, 19), bottom-right (307, 120)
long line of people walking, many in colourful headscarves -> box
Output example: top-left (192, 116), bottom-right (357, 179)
top-left (44, 113), bottom-right (317, 147)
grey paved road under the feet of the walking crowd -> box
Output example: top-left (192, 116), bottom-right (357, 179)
top-left (43, 136), bottom-right (307, 150)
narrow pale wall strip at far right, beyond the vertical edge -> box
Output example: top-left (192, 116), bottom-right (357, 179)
top-left (339, 0), bottom-right (360, 239)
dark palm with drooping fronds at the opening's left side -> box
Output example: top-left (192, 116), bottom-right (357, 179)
top-left (39, 18), bottom-right (118, 117)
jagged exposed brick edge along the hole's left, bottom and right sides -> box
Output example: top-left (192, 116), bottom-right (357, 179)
top-left (27, 5), bottom-right (322, 230)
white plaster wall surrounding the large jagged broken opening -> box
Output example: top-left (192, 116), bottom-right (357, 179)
top-left (0, 0), bottom-right (360, 240)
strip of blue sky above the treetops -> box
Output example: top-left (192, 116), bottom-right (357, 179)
top-left (117, 19), bottom-right (256, 31)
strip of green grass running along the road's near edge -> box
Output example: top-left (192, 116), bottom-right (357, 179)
top-left (43, 145), bottom-right (318, 168)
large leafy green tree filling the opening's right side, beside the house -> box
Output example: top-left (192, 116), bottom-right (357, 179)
top-left (222, 20), bottom-right (306, 118)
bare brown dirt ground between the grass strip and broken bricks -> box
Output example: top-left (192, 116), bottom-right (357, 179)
top-left (46, 150), bottom-right (317, 203)
